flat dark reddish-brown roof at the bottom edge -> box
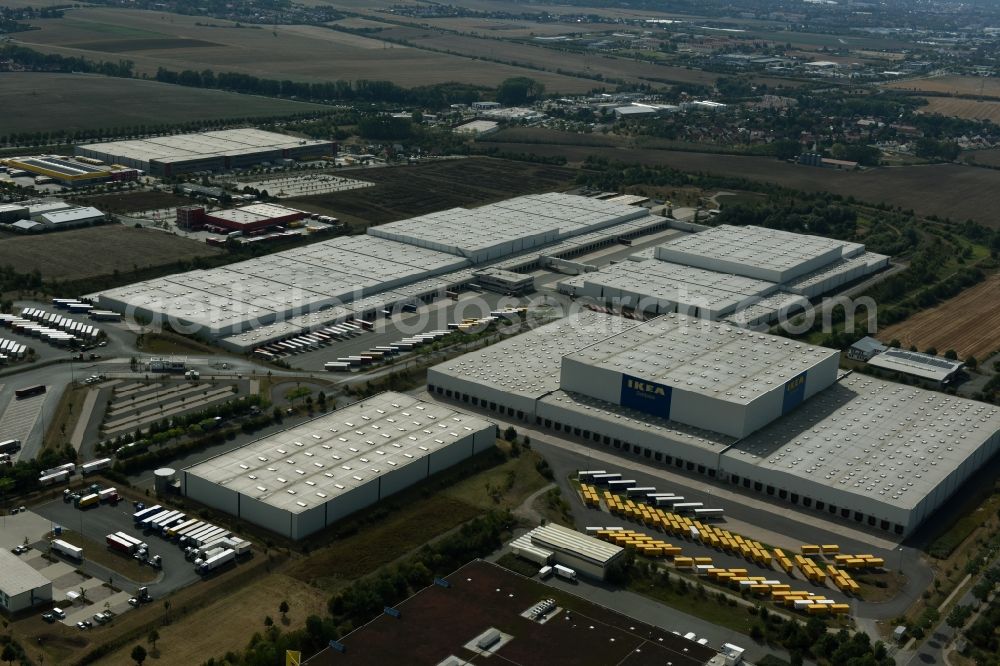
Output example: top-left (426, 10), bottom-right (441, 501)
top-left (304, 560), bottom-right (717, 666)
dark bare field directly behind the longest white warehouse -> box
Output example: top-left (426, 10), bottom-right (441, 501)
top-left (286, 158), bottom-right (576, 227)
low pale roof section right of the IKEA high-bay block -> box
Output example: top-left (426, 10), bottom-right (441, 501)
top-left (722, 373), bottom-right (1000, 522)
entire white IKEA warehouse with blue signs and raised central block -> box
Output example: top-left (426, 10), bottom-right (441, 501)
top-left (427, 312), bottom-right (1000, 534)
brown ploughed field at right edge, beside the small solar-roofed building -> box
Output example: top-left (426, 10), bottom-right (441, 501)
top-left (878, 273), bottom-right (1000, 359)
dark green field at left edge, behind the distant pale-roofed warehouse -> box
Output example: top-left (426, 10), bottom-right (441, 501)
top-left (0, 72), bottom-right (329, 134)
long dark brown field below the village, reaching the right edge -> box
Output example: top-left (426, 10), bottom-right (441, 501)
top-left (476, 131), bottom-right (1000, 227)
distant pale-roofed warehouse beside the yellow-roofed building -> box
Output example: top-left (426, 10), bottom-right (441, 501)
top-left (75, 129), bottom-right (337, 177)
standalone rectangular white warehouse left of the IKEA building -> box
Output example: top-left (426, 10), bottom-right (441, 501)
top-left (181, 393), bottom-right (496, 539)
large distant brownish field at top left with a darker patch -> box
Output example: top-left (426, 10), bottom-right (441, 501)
top-left (15, 8), bottom-right (599, 93)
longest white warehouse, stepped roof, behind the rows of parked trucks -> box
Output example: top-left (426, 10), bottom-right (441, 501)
top-left (91, 193), bottom-right (669, 352)
